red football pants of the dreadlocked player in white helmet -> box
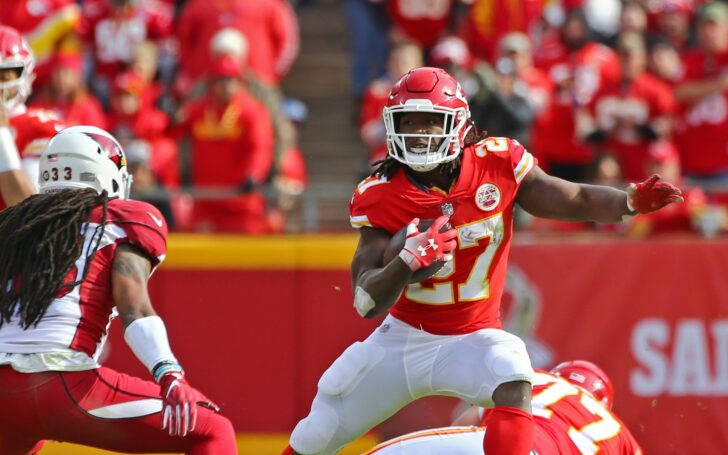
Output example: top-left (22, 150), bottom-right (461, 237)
top-left (0, 365), bottom-right (238, 455)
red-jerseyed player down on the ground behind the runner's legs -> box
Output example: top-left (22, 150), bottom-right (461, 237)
top-left (366, 360), bottom-right (642, 455)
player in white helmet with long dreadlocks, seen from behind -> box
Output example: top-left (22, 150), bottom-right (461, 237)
top-left (0, 126), bottom-right (237, 455)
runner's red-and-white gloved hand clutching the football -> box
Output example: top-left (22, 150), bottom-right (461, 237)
top-left (399, 216), bottom-right (457, 272)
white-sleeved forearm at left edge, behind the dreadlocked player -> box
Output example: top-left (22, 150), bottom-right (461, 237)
top-left (0, 106), bottom-right (36, 207)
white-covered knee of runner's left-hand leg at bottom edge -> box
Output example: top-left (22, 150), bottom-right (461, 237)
top-left (289, 401), bottom-right (339, 455)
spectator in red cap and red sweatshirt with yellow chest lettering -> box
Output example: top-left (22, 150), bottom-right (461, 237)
top-left (180, 56), bottom-right (273, 234)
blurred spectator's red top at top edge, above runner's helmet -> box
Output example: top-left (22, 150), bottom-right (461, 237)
top-left (387, 0), bottom-right (457, 49)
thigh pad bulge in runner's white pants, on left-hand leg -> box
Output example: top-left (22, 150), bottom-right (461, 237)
top-left (318, 341), bottom-right (384, 397)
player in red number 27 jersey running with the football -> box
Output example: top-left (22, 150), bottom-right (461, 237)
top-left (284, 67), bottom-right (682, 455)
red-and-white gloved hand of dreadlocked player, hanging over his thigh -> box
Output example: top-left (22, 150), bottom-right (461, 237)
top-left (159, 371), bottom-right (220, 437)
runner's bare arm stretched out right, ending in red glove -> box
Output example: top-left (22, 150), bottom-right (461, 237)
top-left (516, 167), bottom-right (683, 223)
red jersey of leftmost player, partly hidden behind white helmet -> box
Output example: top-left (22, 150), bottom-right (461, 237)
top-left (0, 106), bottom-right (65, 210)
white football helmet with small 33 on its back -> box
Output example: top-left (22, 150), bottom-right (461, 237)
top-left (38, 125), bottom-right (132, 199)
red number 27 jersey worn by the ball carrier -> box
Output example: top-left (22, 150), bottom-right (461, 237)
top-left (350, 138), bottom-right (535, 335)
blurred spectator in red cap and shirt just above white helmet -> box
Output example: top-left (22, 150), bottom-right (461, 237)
top-left (109, 71), bottom-right (180, 188)
